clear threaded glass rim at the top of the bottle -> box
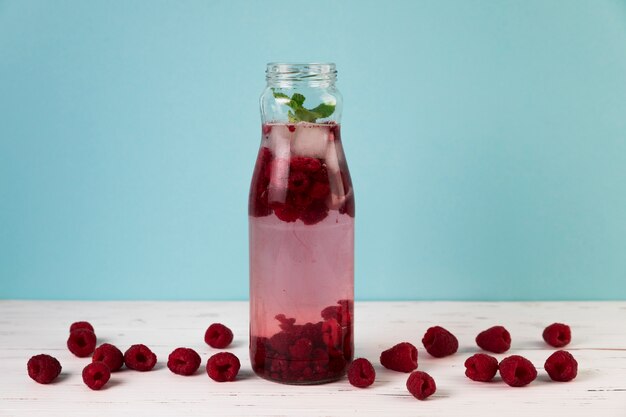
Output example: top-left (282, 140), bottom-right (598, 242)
top-left (265, 63), bottom-right (337, 88)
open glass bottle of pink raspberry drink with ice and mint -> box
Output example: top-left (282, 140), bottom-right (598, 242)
top-left (248, 63), bottom-right (355, 384)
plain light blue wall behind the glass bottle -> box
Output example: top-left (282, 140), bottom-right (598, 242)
top-left (0, 0), bottom-right (626, 300)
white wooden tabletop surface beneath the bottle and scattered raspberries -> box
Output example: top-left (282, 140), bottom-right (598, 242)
top-left (0, 301), bottom-right (626, 417)
